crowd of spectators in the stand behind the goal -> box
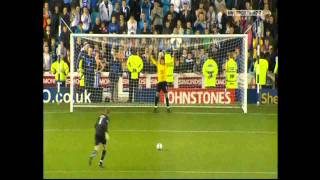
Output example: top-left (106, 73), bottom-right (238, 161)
top-left (43, 0), bottom-right (278, 78)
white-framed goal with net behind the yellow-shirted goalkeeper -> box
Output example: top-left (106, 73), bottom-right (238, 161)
top-left (69, 34), bottom-right (247, 113)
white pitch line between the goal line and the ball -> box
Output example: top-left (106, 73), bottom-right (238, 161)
top-left (43, 129), bottom-right (277, 134)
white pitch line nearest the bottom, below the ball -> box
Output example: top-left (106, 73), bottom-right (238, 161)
top-left (44, 170), bottom-right (277, 174)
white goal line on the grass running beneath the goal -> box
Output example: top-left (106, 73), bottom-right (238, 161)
top-left (43, 111), bottom-right (278, 116)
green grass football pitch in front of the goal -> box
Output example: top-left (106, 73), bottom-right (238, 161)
top-left (43, 104), bottom-right (278, 179)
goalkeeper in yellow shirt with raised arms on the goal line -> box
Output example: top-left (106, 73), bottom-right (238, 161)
top-left (150, 52), bottom-right (171, 112)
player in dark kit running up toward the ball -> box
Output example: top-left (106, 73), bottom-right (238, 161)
top-left (89, 110), bottom-right (110, 167)
